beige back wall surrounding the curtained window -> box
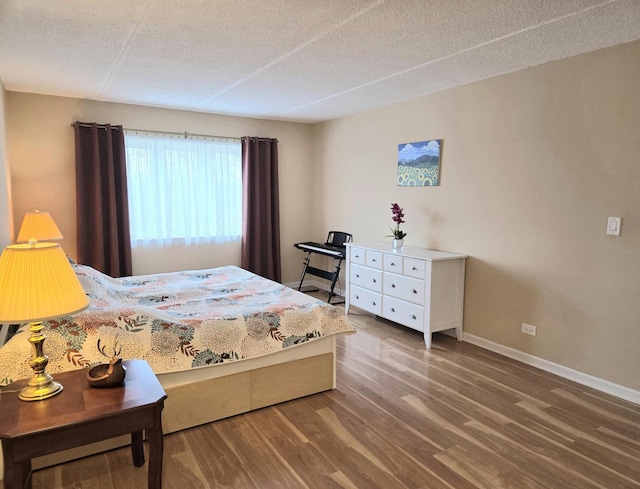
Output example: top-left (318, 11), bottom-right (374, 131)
top-left (6, 92), bottom-right (316, 282)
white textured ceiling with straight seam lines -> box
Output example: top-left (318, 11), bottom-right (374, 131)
top-left (0, 0), bottom-right (640, 122)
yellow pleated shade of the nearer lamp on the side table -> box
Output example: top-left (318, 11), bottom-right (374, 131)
top-left (0, 243), bottom-right (89, 324)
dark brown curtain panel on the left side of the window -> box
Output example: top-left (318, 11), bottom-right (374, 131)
top-left (73, 122), bottom-right (131, 277)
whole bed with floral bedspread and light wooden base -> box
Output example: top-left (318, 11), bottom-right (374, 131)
top-left (0, 264), bottom-right (355, 474)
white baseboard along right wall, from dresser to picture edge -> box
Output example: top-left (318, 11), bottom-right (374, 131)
top-left (462, 333), bottom-right (640, 405)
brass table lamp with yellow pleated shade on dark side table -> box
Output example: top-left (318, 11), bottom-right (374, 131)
top-left (0, 241), bottom-right (89, 401)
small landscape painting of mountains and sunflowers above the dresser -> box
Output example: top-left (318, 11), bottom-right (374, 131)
top-left (397, 139), bottom-right (442, 187)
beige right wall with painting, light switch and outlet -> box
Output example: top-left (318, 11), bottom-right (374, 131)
top-left (315, 42), bottom-right (640, 390)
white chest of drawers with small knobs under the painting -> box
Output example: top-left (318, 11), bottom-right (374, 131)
top-left (345, 243), bottom-right (467, 348)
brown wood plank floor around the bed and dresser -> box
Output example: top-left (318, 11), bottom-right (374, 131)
top-left (6, 304), bottom-right (640, 489)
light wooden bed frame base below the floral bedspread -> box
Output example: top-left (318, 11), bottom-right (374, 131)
top-left (15, 335), bottom-right (337, 474)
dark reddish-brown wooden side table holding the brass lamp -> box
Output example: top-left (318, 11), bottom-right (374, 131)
top-left (0, 360), bottom-right (167, 489)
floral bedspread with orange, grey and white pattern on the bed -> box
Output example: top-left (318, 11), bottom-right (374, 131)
top-left (0, 265), bottom-right (355, 385)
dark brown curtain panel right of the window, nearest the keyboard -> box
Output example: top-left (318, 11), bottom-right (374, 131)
top-left (241, 137), bottom-right (281, 282)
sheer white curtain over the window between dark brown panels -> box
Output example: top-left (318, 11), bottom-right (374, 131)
top-left (125, 131), bottom-right (242, 247)
